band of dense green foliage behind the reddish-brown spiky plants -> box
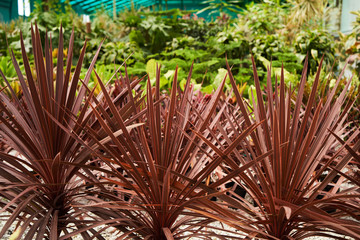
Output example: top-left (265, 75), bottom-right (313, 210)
top-left (0, 1), bottom-right (352, 95)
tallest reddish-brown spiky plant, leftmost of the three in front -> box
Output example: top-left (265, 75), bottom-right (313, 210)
top-left (0, 25), bottom-right (111, 239)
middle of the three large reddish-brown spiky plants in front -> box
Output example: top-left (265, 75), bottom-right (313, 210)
top-left (75, 64), bottom-right (268, 239)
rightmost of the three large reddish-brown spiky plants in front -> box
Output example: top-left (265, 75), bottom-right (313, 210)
top-left (195, 57), bottom-right (360, 239)
